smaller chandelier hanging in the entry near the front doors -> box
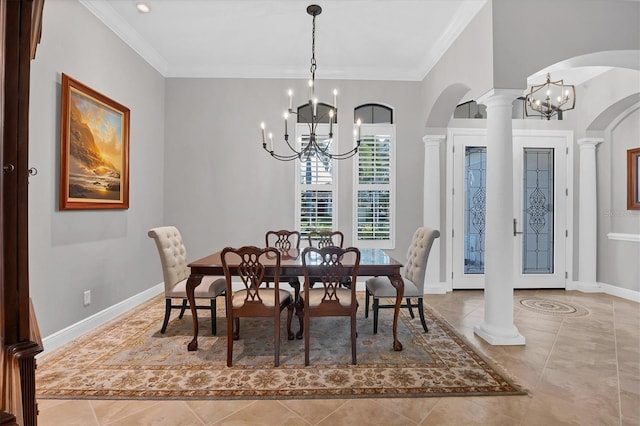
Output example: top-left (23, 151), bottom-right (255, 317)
top-left (524, 74), bottom-right (576, 120)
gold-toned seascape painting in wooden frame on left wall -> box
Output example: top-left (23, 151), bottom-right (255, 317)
top-left (60, 74), bottom-right (130, 210)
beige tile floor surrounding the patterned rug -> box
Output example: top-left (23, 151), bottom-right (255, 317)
top-left (38, 290), bottom-right (640, 426)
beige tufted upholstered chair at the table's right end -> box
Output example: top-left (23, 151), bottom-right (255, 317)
top-left (364, 227), bottom-right (440, 334)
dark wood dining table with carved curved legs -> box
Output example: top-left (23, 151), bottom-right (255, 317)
top-left (187, 248), bottom-right (404, 351)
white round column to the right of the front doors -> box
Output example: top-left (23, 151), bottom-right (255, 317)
top-left (577, 138), bottom-right (604, 292)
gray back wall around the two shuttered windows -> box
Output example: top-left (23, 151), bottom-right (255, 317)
top-left (164, 79), bottom-right (424, 259)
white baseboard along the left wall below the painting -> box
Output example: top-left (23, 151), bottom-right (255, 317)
top-left (38, 283), bottom-right (164, 356)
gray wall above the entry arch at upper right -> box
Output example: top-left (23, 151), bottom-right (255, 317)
top-left (492, 0), bottom-right (640, 89)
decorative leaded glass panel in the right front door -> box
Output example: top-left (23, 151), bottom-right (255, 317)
top-left (522, 148), bottom-right (554, 274)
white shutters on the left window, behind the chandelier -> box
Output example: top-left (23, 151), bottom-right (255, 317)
top-left (296, 124), bottom-right (338, 237)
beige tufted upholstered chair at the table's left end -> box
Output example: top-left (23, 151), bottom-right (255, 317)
top-left (147, 226), bottom-right (227, 335)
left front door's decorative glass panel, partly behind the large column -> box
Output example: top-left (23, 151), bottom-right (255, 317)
top-left (464, 147), bottom-right (487, 274)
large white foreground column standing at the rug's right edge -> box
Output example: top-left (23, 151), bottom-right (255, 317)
top-left (474, 89), bottom-right (525, 345)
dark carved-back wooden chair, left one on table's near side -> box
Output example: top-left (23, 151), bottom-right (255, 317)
top-left (221, 246), bottom-right (294, 367)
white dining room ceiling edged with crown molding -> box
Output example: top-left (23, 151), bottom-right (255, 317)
top-left (80, 0), bottom-right (486, 81)
